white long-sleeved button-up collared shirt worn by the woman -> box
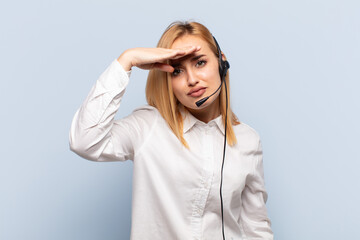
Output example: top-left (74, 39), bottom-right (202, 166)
top-left (70, 59), bottom-right (273, 240)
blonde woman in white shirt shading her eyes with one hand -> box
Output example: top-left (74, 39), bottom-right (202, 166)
top-left (70, 22), bottom-right (273, 240)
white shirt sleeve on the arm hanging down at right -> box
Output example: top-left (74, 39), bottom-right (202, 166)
top-left (240, 139), bottom-right (274, 240)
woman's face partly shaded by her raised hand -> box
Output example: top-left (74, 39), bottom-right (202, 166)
top-left (170, 35), bottom-right (221, 117)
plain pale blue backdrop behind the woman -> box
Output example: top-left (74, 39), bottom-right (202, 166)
top-left (0, 0), bottom-right (360, 240)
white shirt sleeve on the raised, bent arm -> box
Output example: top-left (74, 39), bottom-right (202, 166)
top-left (69, 59), bottom-right (153, 161)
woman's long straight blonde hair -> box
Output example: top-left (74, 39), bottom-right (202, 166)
top-left (146, 22), bottom-right (240, 148)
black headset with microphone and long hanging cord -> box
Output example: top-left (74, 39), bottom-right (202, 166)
top-left (196, 36), bottom-right (230, 240)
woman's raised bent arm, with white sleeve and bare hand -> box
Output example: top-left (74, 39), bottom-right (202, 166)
top-left (69, 47), bottom-right (200, 161)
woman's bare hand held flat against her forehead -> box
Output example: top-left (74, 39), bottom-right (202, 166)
top-left (117, 46), bottom-right (200, 72)
